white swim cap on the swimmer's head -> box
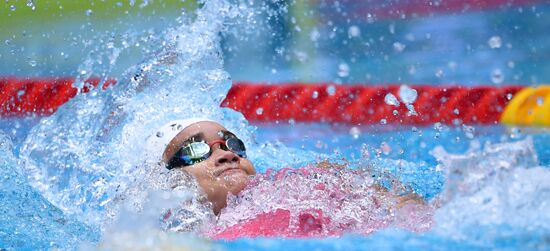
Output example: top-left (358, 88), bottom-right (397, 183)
top-left (145, 118), bottom-right (216, 165)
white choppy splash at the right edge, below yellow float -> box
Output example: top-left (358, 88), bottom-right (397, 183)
top-left (434, 138), bottom-right (550, 247)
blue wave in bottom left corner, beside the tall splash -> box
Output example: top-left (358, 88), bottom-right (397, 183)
top-left (0, 131), bottom-right (99, 250)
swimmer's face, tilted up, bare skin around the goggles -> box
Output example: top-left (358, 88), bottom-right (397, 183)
top-left (163, 121), bottom-right (256, 214)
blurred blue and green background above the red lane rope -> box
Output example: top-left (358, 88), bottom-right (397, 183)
top-left (0, 0), bottom-right (550, 85)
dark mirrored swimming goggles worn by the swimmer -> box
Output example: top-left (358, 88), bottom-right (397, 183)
top-left (166, 136), bottom-right (246, 169)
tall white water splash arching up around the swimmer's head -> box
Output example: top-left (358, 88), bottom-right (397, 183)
top-left (16, 1), bottom-right (319, 241)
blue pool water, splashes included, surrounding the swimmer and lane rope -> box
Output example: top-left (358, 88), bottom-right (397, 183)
top-left (0, 1), bottom-right (550, 250)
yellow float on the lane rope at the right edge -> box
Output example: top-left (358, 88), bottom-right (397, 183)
top-left (500, 85), bottom-right (550, 126)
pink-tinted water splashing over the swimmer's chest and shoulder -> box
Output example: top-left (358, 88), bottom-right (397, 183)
top-left (215, 166), bottom-right (433, 236)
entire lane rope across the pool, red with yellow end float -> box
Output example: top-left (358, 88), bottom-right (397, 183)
top-left (0, 78), bottom-right (550, 125)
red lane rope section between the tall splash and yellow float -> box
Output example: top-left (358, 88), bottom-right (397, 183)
top-left (222, 83), bottom-right (523, 125)
